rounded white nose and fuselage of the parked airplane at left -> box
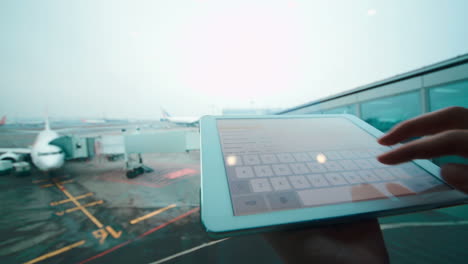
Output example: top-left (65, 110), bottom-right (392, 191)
top-left (31, 129), bottom-right (65, 171)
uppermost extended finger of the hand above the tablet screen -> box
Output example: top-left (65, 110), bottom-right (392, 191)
top-left (378, 107), bottom-right (468, 146)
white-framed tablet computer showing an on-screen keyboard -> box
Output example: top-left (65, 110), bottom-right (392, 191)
top-left (200, 115), bottom-right (467, 236)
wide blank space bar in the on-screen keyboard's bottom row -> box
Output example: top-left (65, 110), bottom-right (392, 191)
top-left (297, 186), bottom-right (353, 206)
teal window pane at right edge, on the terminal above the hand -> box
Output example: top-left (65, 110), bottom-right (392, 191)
top-left (429, 80), bottom-right (468, 111)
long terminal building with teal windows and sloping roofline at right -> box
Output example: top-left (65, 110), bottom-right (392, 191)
top-left (278, 54), bottom-right (468, 165)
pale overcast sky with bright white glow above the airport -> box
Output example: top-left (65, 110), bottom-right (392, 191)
top-left (0, 0), bottom-right (468, 118)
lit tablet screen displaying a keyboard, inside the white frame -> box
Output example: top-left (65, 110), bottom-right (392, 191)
top-left (217, 117), bottom-right (451, 215)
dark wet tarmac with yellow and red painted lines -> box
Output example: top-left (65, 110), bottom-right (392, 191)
top-left (0, 122), bottom-right (468, 264)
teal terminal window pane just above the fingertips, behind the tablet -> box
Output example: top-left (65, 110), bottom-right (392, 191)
top-left (361, 92), bottom-right (421, 132)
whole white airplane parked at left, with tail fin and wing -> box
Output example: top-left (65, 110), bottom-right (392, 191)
top-left (0, 119), bottom-right (65, 171)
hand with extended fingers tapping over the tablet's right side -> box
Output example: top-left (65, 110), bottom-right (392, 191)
top-left (378, 107), bottom-right (468, 193)
